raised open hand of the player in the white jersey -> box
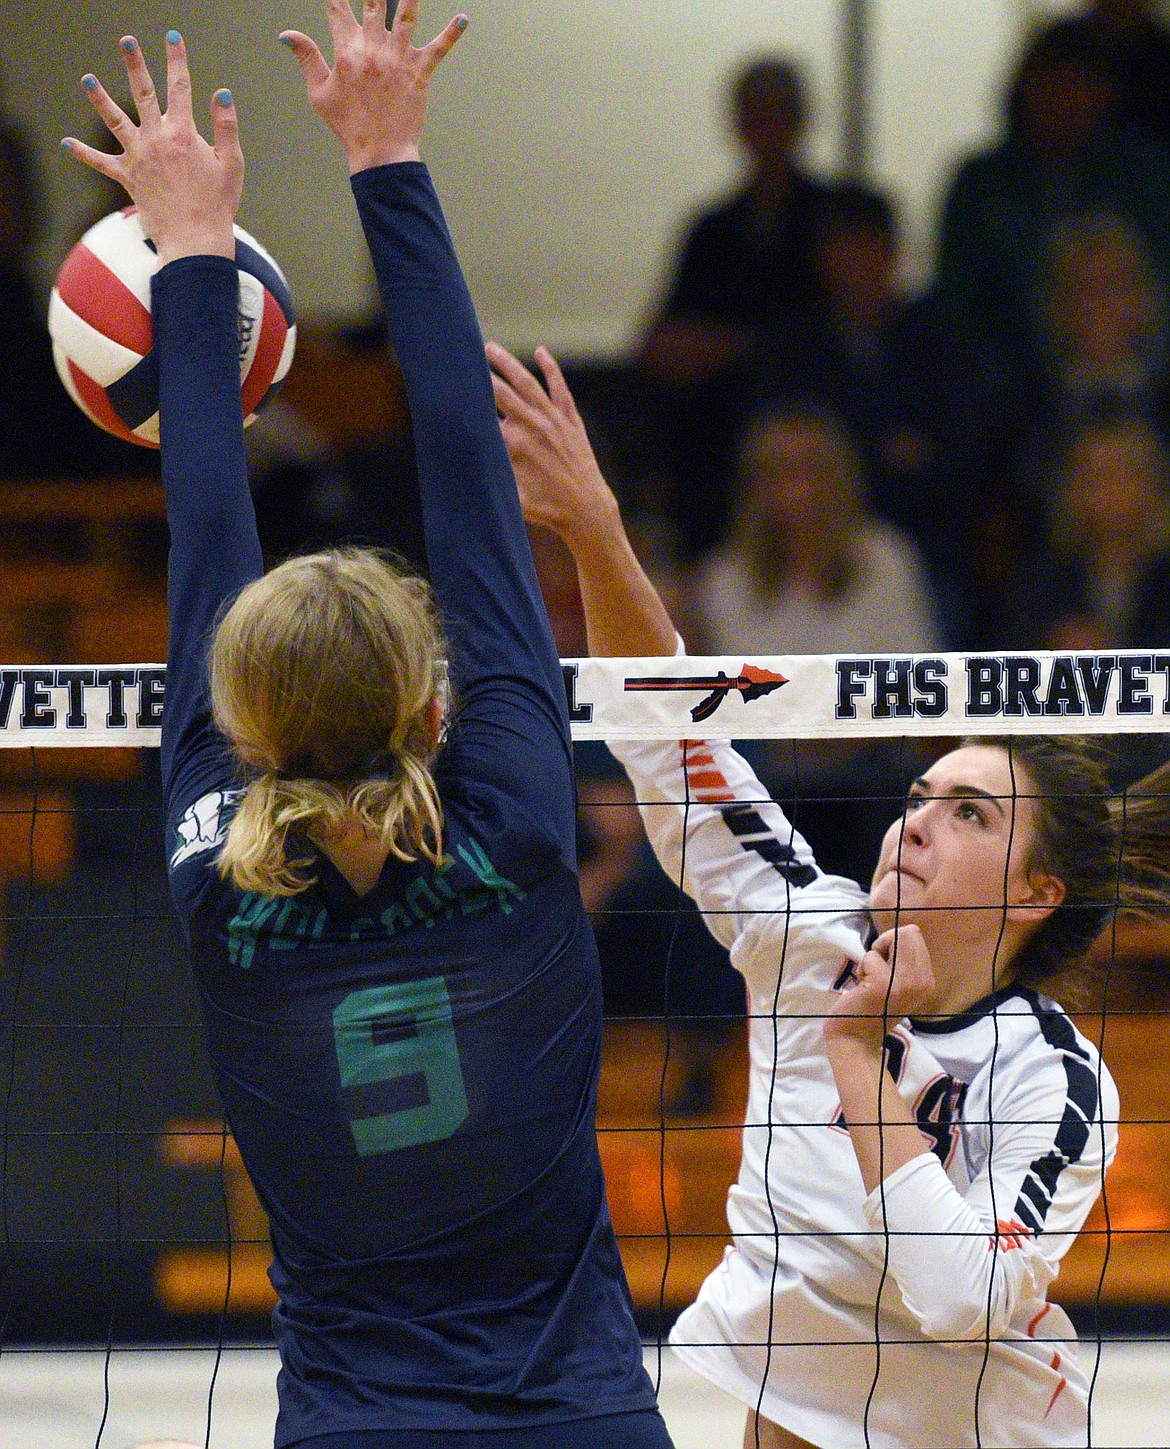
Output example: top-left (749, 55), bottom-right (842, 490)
top-left (487, 342), bottom-right (616, 552)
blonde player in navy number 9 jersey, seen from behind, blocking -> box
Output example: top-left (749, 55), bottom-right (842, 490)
top-left (68, 11), bottom-right (670, 1449)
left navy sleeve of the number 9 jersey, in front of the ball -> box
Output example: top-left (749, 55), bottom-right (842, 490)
top-left (151, 256), bottom-right (264, 820)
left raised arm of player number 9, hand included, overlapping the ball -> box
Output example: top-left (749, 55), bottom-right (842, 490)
top-left (65, 30), bottom-right (262, 800)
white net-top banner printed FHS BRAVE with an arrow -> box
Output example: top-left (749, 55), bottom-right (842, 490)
top-left (0, 649), bottom-right (1170, 748)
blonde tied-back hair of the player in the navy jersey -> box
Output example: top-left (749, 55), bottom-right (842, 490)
top-left (210, 549), bottom-right (442, 895)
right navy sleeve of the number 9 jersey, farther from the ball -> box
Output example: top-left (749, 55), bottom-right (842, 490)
top-left (352, 162), bottom-right (576, 869)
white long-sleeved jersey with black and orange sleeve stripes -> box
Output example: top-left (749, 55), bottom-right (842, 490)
top-left (610, 742), bottom-right (1118, 1449)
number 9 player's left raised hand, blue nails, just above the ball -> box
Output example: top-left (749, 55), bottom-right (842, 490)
top-left (62, 30), bottom-right (244, 264)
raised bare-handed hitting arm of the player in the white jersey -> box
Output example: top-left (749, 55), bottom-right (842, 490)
top-left (487, 342), bottom-right (864, 991)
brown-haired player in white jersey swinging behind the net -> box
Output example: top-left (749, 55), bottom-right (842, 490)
top-left (489, 346), bottom-right (1170, 1449)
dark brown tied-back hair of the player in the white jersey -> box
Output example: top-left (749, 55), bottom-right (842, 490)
top-left (964, 735), bottom-right (1170, 1009)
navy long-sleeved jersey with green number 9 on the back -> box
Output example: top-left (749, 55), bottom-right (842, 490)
top-left (154, 164), bottom-right (654, 1445)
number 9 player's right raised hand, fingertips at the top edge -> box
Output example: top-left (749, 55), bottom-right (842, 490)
top-left (280, 0), bottom-right (467, 175)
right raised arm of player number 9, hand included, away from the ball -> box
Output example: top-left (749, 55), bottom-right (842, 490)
top-left (283, 0), bottom-right (568, 724)
